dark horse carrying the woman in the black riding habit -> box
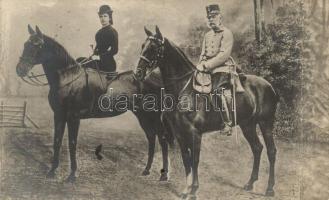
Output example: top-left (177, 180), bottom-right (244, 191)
top-left (16, 25), bottom-right (168, 182)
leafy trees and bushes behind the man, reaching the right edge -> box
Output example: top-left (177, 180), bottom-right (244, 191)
top-left (179, 0), bottom-right (329, 140)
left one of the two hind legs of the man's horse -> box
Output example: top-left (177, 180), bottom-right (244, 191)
top-left (240, 121), bottom-right (263, 190)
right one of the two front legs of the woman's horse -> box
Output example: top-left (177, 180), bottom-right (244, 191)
top-left (66, 117), bottom-right (80, 183)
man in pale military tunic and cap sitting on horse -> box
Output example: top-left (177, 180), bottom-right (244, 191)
top-left (197, 4), bottom-right (244, 133)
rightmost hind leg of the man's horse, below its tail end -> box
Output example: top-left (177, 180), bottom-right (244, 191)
top-left (259, 119), bottom-right (276, 196)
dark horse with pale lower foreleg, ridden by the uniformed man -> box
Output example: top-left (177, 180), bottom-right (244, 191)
top-left (138, 27), bottom-right (278, 199)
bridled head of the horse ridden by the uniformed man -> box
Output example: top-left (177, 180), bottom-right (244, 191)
top-left (136, 26), bottom-right (165, 80)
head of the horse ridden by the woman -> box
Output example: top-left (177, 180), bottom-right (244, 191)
top-left (16, 25), bottom-right (45, 77)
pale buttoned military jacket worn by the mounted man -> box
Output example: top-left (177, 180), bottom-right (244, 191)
top-left (199, 26), bottom-right (234, 73)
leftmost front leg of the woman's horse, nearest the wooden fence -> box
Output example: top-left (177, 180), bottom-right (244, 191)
top-left (47, 112), bottom-right (66, 178)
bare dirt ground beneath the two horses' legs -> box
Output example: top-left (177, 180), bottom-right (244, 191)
top-left (0, 97), bottom-right (329, 200)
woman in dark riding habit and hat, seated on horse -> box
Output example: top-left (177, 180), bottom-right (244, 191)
top-left (94, 5), bottom-right (118, 72)
